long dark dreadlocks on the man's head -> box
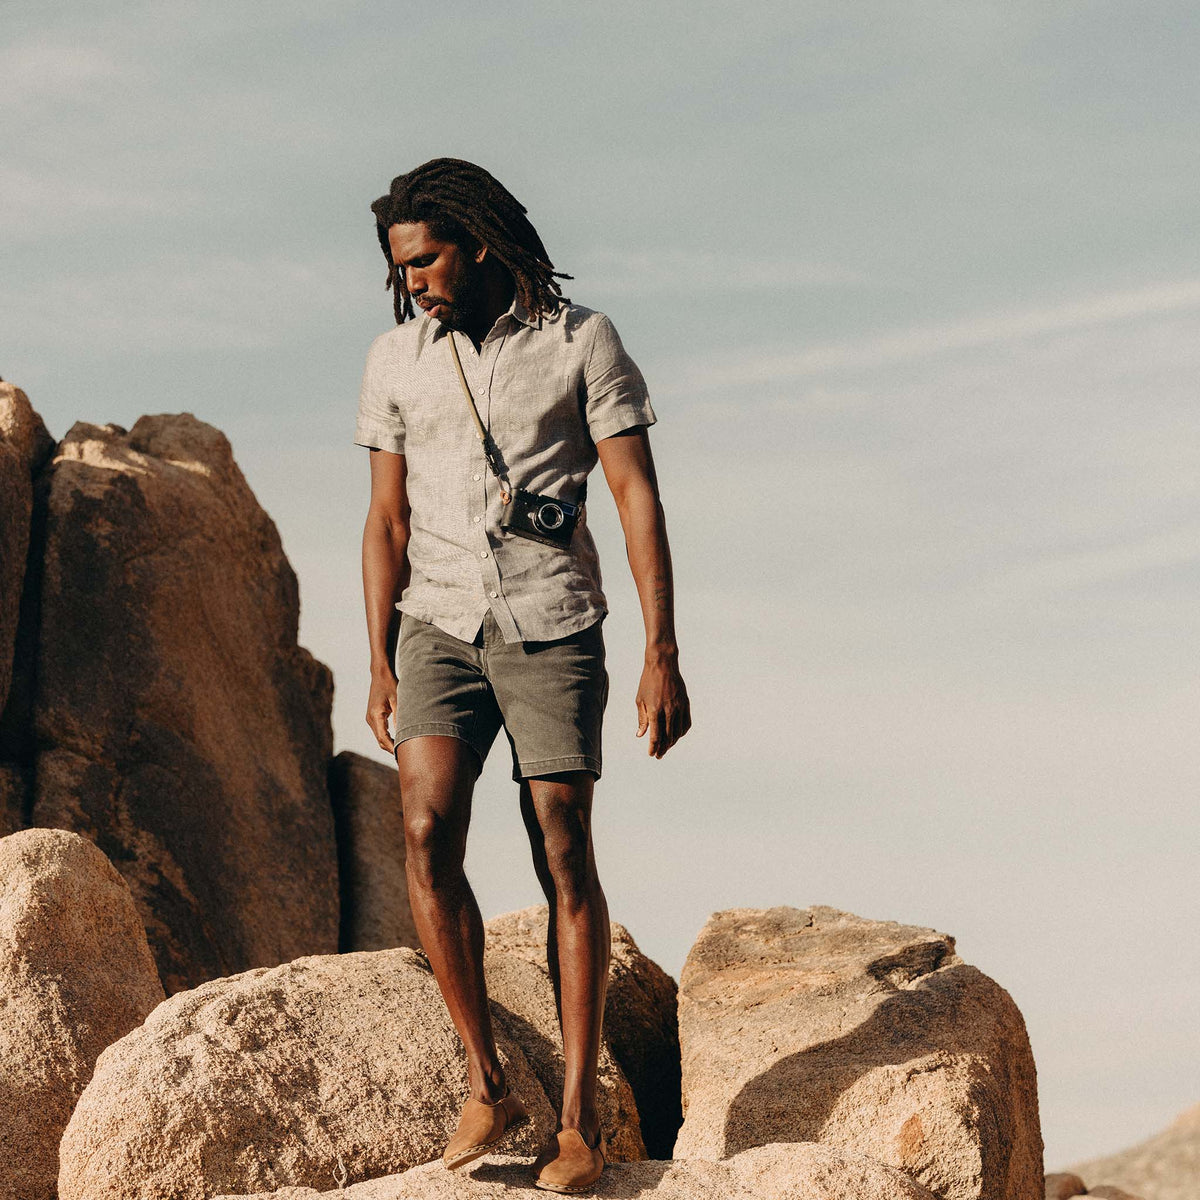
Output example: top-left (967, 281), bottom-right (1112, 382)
top-left (371, 158), bottom-right (574, 325)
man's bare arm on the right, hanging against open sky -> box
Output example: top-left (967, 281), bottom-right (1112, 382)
top-left (596, 425), bottom-right (691, 758)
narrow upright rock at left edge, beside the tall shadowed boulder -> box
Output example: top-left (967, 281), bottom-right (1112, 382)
top-left (0, 383), bottom-right (54, 836)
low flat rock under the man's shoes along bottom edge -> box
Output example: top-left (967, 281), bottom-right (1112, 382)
top-left (215, 1144), bottom-right (936, 1200)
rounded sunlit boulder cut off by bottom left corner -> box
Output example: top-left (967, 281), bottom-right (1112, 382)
top-left (0, 829), bottom-right (163, 1200)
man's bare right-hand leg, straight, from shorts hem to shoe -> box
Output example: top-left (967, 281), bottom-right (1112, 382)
top-left (521, 770), bottom-right (611, 1146)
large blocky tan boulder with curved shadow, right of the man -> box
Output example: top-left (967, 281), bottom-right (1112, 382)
top-left (674, 907), bottom-right (1043, 1200)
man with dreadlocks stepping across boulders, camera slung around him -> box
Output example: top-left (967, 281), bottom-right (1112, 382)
top-left (354, 158), bottom-right (691, 1192)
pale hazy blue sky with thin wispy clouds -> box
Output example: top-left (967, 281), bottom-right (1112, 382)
top-left (0, 0), bottom-right (1200, 1169)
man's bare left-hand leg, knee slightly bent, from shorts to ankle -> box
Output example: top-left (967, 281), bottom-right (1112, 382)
top-left (396, 736), bottom-right (504, 1104)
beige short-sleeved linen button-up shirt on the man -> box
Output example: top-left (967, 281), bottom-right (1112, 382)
top-left (354, 299), bottom-right (656, 642)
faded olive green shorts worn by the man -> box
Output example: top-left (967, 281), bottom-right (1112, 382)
top-left (394, 612), bottom-right (608, 781)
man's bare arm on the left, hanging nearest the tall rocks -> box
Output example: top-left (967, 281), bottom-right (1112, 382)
top-left (362, 450), bottom-right (410, 754)
